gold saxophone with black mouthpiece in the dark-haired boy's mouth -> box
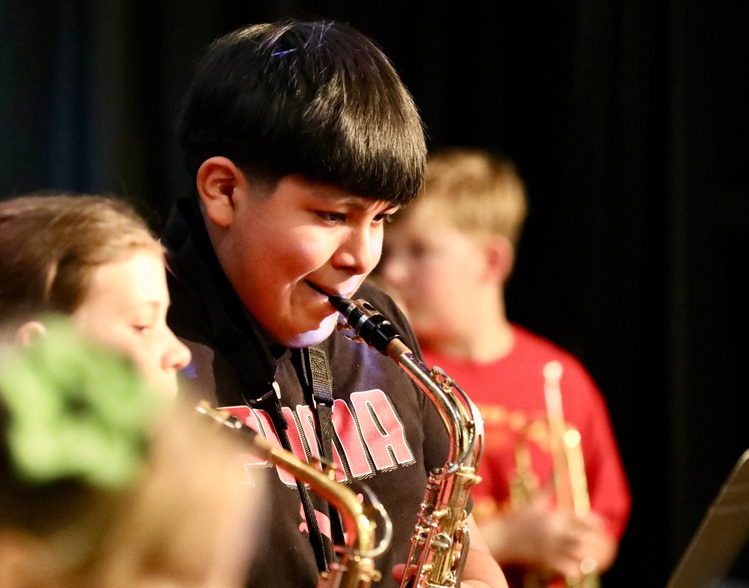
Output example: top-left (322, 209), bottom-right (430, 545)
top-left (329, 296), bottom-right (483, 588)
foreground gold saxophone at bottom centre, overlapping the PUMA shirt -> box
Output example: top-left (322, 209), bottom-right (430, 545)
top-left (196, 400), bottom-right (393, 588)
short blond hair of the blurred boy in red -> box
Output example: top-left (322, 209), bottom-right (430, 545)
top-left (420, 147), bottom-right (528, 247)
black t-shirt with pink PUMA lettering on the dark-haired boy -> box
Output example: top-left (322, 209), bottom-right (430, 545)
top-left (164, 199), bottom-right (448, 588)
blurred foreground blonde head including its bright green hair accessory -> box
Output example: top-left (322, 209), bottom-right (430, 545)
top-left (0, 316), bottom-right (256, 588)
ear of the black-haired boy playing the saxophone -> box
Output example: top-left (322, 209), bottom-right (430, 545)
top-left (196, 156), bottom-right (246, 227)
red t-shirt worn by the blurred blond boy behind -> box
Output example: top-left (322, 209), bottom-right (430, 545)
top-left (423, 325), bottom-right (631, 539)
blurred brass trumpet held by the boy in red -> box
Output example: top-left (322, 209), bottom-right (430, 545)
top-left (509, 361), bottom-right (600, 588)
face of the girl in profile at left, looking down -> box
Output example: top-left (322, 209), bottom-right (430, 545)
top-left (73, 249), bottom-right (191, 395)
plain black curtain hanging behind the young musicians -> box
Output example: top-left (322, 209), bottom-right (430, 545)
top-left (0, 0), bottom-right (749, 586)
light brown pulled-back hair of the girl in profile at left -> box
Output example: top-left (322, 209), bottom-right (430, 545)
top-left (0, 193), bottom-right (163, 319)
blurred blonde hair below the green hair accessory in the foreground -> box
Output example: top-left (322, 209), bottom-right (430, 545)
top-left (0, 400), bottom-right (254, 588)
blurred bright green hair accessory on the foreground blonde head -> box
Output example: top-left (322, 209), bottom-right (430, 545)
top-left (0, 317), bottom-right (166, 488)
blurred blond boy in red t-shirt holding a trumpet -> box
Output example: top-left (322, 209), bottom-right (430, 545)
top-left (380, 148), bottom-right (631, 586)
